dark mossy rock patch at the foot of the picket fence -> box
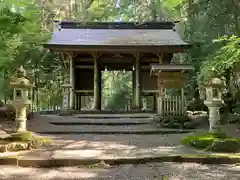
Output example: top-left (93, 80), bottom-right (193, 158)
top-left (154, 115), bottom-right (195, 129)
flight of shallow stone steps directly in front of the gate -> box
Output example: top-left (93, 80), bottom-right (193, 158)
top-left (30, 114), bottom-right (194, 134)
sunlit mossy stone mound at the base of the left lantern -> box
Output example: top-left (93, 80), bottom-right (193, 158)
top-left (0, 131), bottom-right (52, 152)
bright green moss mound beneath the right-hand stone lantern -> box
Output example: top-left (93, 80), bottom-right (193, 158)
top-left (182, 133), bottom-right (240, 153)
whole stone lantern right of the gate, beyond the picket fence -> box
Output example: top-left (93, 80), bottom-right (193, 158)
top-left (204, 78), bottom-right (224, 132)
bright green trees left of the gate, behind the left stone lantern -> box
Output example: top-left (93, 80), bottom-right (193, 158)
top-left (0, 0), bottom-right (65, 107)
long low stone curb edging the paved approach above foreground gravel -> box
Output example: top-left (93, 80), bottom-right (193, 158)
top-left (0, 155), bottom-right (240, 167)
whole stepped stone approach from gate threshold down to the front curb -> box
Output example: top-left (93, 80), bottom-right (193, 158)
top-left (0, 114), bottom-right (239, 167)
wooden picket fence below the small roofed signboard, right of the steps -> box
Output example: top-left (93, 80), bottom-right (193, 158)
top-left (158, 96), bottom-right (186, 115)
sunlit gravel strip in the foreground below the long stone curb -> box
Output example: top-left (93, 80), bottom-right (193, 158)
top-left (0, 163), bottom-right (240, 180)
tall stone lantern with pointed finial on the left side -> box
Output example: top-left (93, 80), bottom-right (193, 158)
top-left (10, 66), bottom-right (34, 132)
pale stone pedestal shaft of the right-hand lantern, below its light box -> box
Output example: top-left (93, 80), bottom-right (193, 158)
top-left (204, 100), bottom-right (223, 132)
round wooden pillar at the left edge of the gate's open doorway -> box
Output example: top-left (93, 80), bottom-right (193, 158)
top-left (94, 55), bottom-right (101, 110)
